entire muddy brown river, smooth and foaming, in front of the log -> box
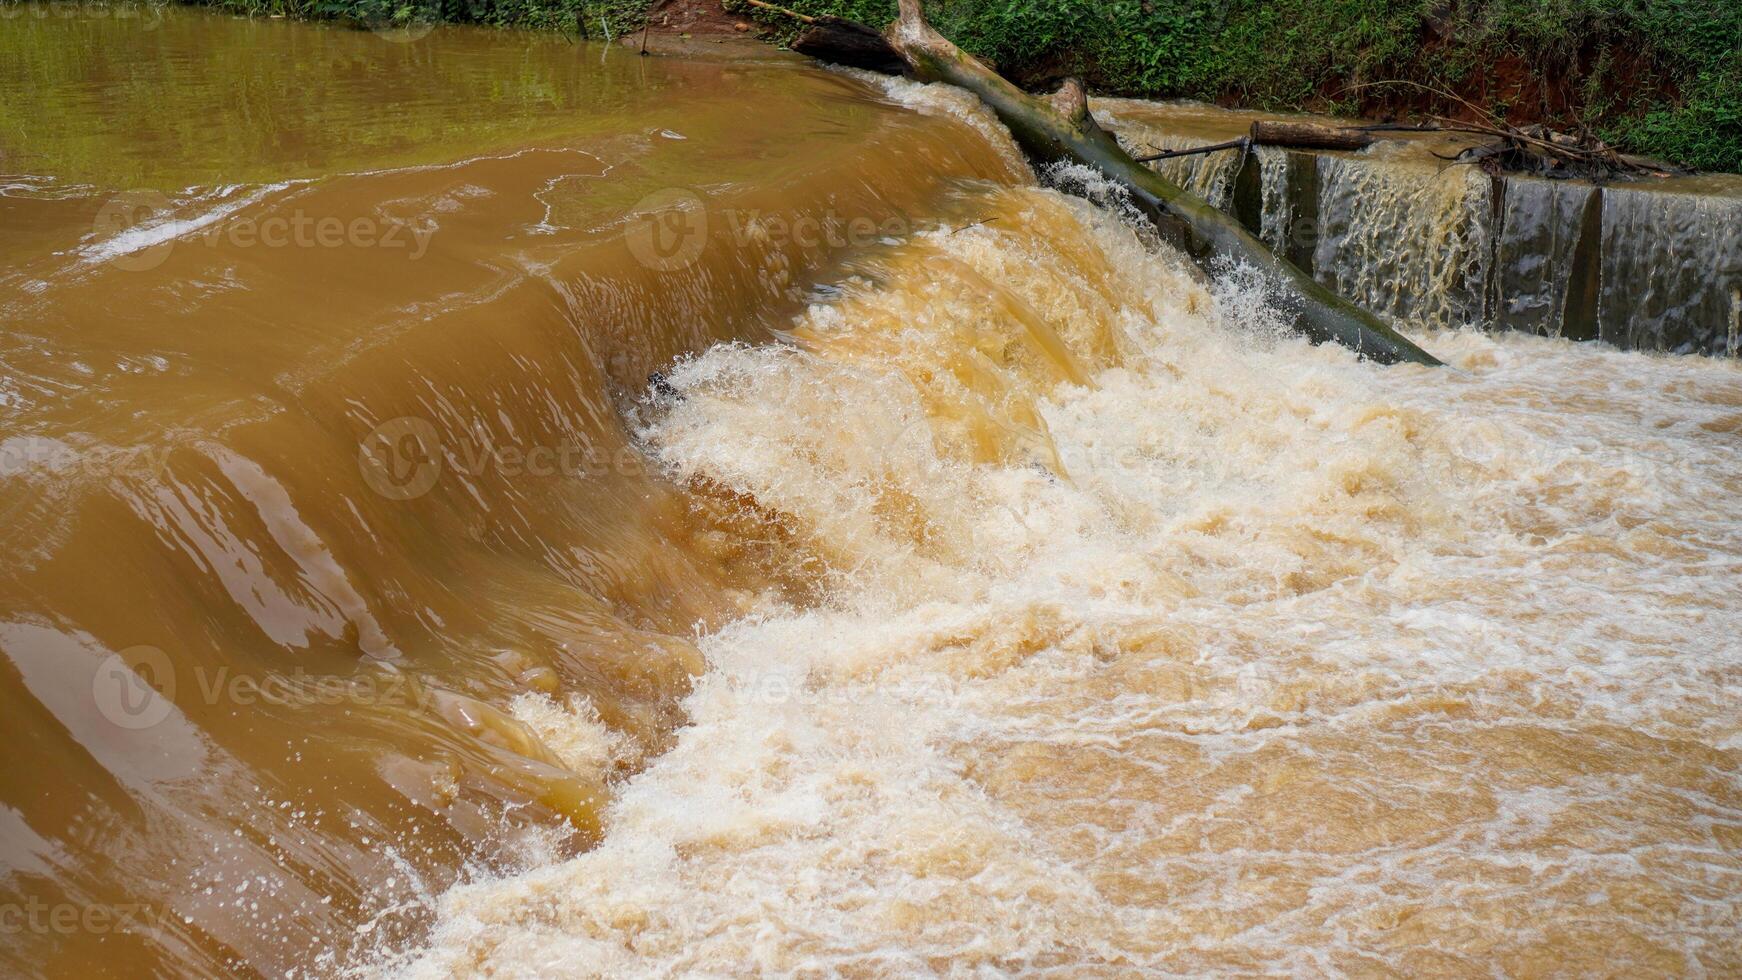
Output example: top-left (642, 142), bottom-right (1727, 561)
top-left (0, 7), bottom-right (1742, 977)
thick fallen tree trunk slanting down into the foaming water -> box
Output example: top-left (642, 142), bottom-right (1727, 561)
top-left (793, 0), bottom-right (1439, 364)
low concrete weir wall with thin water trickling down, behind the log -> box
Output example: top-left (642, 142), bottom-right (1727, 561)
top-left (1097, 99), bottom-right (1742, 357)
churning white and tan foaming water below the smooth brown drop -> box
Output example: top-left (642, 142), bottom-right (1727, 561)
top-left (381, 74), bottom-right (1742, 977)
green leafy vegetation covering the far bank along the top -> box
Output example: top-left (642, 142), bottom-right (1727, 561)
top-left (166, 0), bottom-right (1742, 172)
